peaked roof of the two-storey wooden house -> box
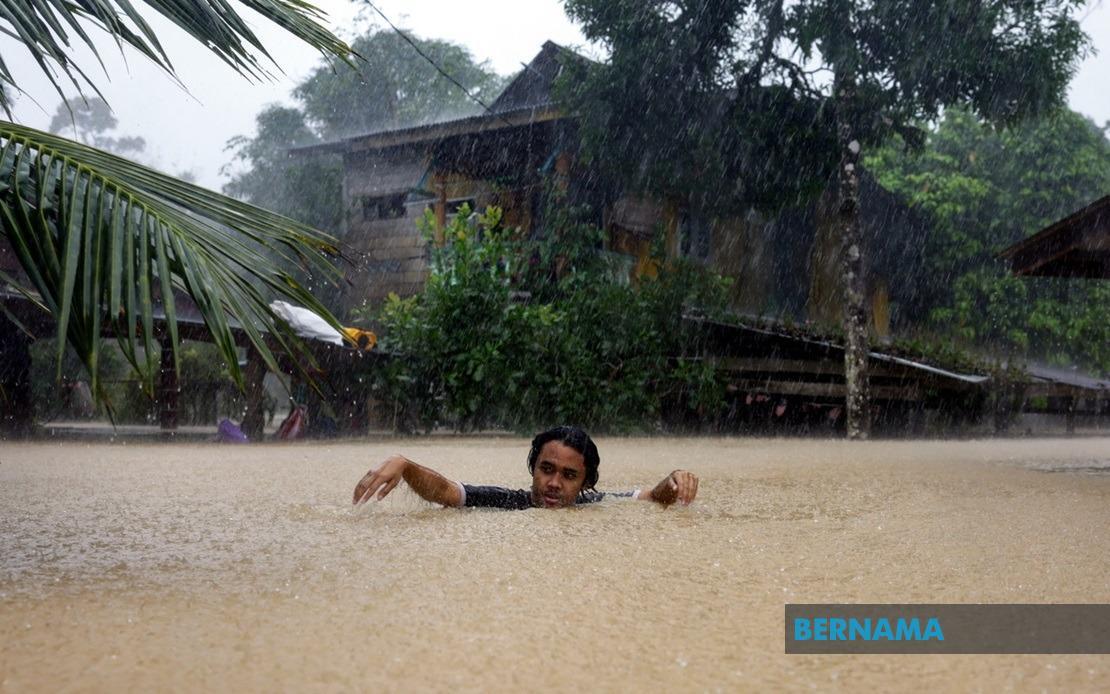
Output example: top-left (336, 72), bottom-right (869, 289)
top-left (290, 41), bottom-right (582, 154)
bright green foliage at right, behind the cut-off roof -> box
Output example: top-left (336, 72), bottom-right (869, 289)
top-left (867, 110), bottom-right (1110, 372)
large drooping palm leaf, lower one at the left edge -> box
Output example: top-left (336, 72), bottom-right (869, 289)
top-left (0, 121), bottom-right (340, 392)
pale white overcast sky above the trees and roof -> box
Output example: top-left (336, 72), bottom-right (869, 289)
top-left (0, 0), bottom-right (1110, 189)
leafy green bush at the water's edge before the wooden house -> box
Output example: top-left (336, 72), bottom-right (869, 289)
top-left (361, 208), bottom-right (726, 431)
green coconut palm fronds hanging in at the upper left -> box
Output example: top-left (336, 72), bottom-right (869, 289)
top-left (0, 0), bottom-right (351, 393)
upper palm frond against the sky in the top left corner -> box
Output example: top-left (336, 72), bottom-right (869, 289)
top-left (0, 0), bottom-right (351, 115)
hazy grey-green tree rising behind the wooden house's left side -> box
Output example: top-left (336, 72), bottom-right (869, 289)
top-left (223, 30), bottom-right (504, 233)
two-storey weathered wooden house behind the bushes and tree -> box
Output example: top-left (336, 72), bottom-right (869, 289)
top-left (306, 42), bottom-right (945, 336)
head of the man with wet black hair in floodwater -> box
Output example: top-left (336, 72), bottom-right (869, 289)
top-left (528, 426), bottom-right (601, 507)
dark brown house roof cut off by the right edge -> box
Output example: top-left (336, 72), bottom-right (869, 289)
top-left (999, 195), bottom-right (1110, 280)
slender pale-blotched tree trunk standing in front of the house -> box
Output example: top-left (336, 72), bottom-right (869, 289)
top-left (834, 74), bottom-right (871, 439)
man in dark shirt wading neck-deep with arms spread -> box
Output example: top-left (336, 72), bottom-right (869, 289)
top-left (354, 426), bottom-right (697, 509)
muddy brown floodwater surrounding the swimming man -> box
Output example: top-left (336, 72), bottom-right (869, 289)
top-left (0, 437), bottom-right (1110, 692)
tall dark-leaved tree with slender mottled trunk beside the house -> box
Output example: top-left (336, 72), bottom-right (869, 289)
top-left (566, 0), bottom-right (1087, 437)
